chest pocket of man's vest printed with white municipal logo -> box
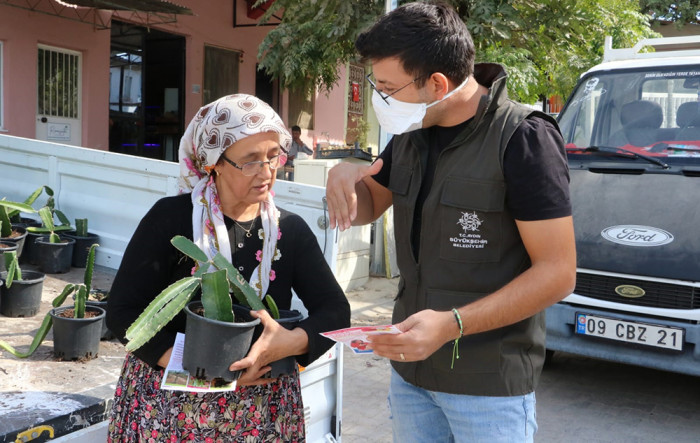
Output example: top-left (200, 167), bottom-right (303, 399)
top-left (439, 177), bottom-right (506, 263)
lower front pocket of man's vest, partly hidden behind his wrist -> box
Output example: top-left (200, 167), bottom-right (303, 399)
top-left (427, 289), bottom-right (504, 374)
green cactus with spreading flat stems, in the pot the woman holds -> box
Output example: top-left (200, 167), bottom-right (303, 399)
top-left (126, 235), bottom-right (279, 351)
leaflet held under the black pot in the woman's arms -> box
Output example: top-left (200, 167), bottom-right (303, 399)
top-left (160, 332), bottom-right (241, 392)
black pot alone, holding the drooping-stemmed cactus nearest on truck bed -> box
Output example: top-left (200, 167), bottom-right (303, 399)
top-left (49, 306), bottom-right (105, 360)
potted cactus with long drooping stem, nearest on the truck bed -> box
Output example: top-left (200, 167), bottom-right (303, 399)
top-left (0, 244), bottom-right (105, 360)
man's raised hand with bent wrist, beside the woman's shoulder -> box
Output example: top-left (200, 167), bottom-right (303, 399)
top-left (326, 159), bottom-right (383, 231)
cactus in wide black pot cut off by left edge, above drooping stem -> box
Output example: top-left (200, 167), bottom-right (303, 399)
top-left (0, 251), bottom-right (46, 317)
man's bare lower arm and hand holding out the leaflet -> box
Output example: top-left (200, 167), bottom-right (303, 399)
top-left (371, 216), bottom-right (576, 361)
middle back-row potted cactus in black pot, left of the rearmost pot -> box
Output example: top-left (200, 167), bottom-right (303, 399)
top-left (27, 206), bottom-right (75, 274)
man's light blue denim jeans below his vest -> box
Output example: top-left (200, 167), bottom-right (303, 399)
top-left (389, 369), bottom-right (537, 443)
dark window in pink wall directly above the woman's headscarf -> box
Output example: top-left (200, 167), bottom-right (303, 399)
top-left (202, 46), bottom-right (241, 104)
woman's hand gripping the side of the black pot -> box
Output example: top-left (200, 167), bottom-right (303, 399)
top-left (229, 310), bottom-right (309, 386)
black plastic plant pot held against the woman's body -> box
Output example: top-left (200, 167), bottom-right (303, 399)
top-left (182, 301), bottom-right (260, 382)
